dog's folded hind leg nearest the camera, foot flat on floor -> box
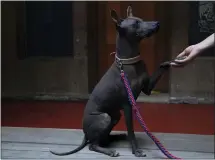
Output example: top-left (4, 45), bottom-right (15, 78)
top-left (87, 113), bottom-right (119, 157)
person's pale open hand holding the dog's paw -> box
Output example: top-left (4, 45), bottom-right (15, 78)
top-left (170, 45), bottom-right (201, 67)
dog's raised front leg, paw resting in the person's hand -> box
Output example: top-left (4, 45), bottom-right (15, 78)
top-left (142, 62), bottom-right (170, 95)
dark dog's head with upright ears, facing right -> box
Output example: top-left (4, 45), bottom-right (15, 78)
top-left (110, 6), bottom-right (159, 42)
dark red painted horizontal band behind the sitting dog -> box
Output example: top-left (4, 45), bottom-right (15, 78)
top-left (1, 101), bottom-right (214, 135)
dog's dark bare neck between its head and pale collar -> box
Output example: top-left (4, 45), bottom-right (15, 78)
top-left (116, 35), bottom-right (140, 59)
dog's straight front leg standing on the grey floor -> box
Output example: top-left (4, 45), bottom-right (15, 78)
top-left (123, 104), bottom-right (146, 157)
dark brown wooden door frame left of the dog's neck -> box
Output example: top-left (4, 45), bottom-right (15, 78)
top-left (87, 1), bottom-right (108, 93)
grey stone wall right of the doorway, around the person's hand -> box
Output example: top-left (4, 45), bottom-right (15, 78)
top-left (170, 2), bottom-right (215, 103)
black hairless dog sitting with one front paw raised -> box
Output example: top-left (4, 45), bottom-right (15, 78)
top-left (50, 6), bottom-right (170, 157)
